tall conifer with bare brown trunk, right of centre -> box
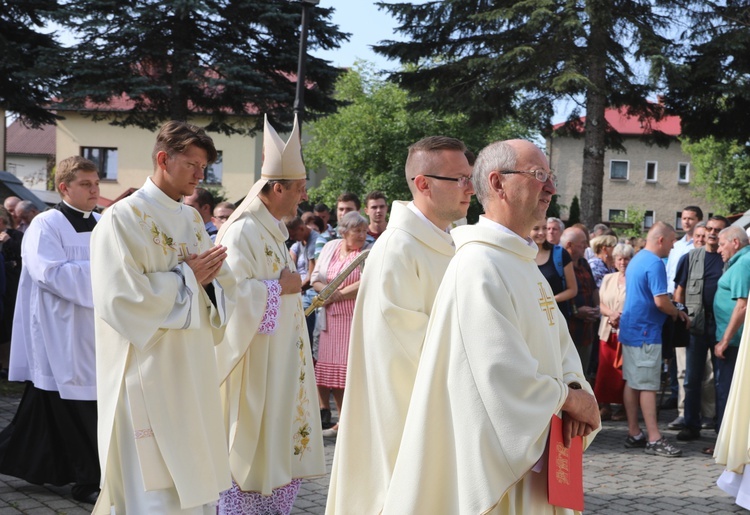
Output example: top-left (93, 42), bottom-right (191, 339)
top-left (375, 0), bottom-right (673, 230)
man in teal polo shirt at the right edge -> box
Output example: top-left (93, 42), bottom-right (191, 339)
top-left (714, 225), bottom-right (750, 432)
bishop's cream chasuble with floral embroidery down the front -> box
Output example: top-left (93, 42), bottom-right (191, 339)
top-left (216, 198), bottom-right (326, 495)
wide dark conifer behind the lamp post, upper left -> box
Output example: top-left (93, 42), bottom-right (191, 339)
top-left (55, 0), bottom-right (348, 134)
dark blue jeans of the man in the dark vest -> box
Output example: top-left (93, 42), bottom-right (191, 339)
top-left (685, 317), bottom-right (720, 431)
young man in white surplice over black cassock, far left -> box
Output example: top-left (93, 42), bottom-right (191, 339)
top-left (0, 156), bottom-right (99, 503)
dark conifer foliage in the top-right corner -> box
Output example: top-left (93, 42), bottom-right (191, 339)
top-left (666, 0), bottom-right (750, 142)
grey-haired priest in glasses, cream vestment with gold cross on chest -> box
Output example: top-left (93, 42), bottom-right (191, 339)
top-left (383, 140), bottom-right (600, 514)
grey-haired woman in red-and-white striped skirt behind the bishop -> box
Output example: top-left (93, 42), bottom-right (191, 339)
top-left (311, 212), bottom-right (367, 438)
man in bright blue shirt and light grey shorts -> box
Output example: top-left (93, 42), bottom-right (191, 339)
top-left (620, 222), bottom-right (690, 458)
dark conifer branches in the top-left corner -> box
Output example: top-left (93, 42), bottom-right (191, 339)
top-left (0, 0), bottom-right (61, 127)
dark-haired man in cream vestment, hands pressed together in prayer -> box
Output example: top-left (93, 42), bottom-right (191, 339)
top-left (91, 121), bottom-right (235, 515)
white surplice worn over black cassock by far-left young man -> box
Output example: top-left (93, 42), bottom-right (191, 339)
top-left (8, 209), bottom-right (99, 401)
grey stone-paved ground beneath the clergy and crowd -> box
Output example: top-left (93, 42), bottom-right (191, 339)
top-left (0, 388), bottom-right (744, 515)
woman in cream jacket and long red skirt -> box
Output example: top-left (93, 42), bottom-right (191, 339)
top-left (594, 243), bottom-right (635, 420)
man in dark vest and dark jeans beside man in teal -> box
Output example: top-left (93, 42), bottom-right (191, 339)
top-left (674, 216), bottom-right (729, 441)
